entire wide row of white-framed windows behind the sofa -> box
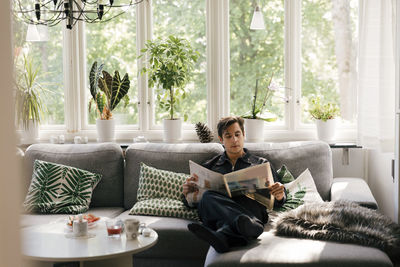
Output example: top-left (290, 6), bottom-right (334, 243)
top-left (14, 0), bottom-right (358, 141)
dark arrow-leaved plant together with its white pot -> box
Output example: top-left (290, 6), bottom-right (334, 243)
top-left (89, 61), bottom-right (130, 142)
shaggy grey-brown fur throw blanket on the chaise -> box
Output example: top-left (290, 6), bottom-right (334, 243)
top-left (274, 201), bottom-right (400, 262)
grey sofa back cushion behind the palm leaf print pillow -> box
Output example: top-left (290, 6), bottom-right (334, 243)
top-left (23, 143), bottom-right (124, 207)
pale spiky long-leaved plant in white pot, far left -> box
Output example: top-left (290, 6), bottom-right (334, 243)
top-left (15, 55), bottom-right (46, 144)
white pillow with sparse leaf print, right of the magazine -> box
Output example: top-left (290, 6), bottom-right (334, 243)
top-left (274, 169), bottom-right (324, 211)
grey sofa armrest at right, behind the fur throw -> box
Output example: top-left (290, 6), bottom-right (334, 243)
top-left (331, 177), bottom-right (378, 209)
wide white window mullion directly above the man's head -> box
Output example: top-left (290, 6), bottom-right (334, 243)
top-left (206, 0), bottom-right (230, 133)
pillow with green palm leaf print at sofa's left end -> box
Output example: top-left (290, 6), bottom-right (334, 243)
top-left (23, 160), bottom-right (101, 214)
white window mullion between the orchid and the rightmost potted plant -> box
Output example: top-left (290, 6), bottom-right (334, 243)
top-left (285, 0), bottom-right (301, 131)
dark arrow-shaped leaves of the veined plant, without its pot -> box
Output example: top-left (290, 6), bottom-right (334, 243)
top-left (89, 61), bottom-right (130, 120)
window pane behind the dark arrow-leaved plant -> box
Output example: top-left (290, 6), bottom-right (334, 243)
top-left (85, 8), bottom-right (138, 125)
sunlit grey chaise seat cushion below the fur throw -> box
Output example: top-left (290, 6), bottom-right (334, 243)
top-left (204, 232), bottom-right (393, 267)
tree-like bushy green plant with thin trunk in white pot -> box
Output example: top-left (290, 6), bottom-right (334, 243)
top-left (139, 35), bottom-right (199, 142)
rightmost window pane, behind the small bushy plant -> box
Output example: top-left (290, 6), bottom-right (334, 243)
top-left (301, 0), bottom-right (358, 123)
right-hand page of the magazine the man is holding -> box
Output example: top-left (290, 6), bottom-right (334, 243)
top-left (224, 162), bottom-right (274, 209)
